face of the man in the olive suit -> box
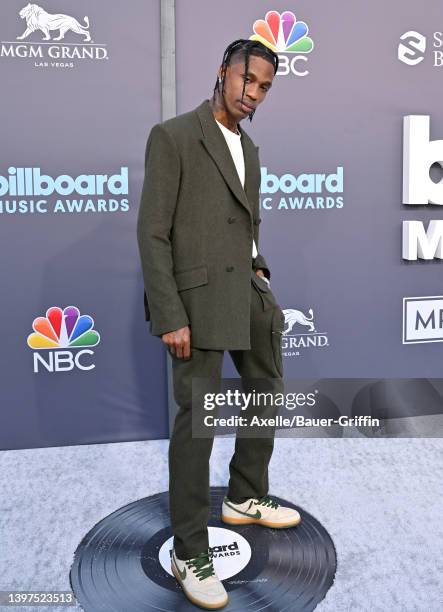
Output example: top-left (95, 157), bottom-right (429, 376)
top-left (219, 55), bottom-right (274, 121)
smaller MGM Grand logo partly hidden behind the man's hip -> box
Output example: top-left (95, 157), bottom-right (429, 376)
top-left (282, 308), bottom-right (329, 357)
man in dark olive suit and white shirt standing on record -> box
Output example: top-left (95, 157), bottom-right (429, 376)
top-left (137, 39), bottom-right (300, 609)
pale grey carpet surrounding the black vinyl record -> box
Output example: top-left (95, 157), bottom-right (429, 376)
top-left (0, 438), bottom-right (443, 612)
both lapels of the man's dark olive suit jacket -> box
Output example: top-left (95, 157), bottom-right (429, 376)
top-left (196, 100), bottom-right (258, 216)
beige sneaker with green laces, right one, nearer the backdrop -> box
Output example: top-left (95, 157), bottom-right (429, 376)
top-left (221, 495), bottom-right (301, 529)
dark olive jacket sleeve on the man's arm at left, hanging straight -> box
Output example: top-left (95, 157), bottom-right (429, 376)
top-left (137, 124), bottom-right (189, 336)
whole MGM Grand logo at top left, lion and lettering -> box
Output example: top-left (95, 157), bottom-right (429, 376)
top-left (0, 4), bottom-right (109, 68)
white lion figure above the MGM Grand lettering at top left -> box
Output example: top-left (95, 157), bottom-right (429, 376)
top-left (17, 4), bottom-right (91, 42)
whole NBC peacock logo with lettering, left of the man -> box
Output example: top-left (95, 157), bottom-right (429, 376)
top-left (27, 306), bottom-right (100, 372)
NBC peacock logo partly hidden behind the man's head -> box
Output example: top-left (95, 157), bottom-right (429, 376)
top-left (249, 11), bottom-right (314, 76)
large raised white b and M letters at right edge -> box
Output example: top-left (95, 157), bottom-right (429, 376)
top-left (402, 115), bottom-right (443, 261)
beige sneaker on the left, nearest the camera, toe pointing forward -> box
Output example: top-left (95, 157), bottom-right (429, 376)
top-left (171, 550), bottom-right (229, 610)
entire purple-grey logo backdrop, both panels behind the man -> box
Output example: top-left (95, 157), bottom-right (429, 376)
top-left (0, 0), bottom-right (443, 449)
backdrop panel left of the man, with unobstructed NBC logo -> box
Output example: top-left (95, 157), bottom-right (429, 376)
top-left (0, 0), bottom-right (168, 449)
